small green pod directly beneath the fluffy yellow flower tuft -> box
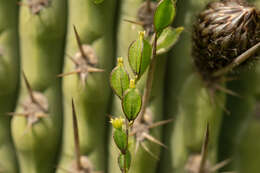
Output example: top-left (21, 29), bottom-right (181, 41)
top-left (113, 129), bottom-right (127, 153)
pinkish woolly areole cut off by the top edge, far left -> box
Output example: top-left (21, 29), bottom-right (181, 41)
top-left (27, 0), bottom-right (51, 14)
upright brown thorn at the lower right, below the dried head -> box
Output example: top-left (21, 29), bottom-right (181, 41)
top-left (199, 123), bottom-right (209, 173)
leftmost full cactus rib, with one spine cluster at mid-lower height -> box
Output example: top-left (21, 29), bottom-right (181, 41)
top-left (12, 0), bottom-right (67, 173)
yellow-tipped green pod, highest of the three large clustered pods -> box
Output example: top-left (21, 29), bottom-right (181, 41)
top-left (128, 32), bottom-right (152, 77)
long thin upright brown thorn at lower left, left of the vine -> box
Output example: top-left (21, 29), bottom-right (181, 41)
top-left (71, 99), bottom-right (82, 170)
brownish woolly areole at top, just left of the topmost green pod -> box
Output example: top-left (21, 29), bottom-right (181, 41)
top-left (137, 2), bottom-right (157, 36)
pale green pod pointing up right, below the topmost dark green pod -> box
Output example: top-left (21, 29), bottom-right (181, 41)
top-left (157, 27), bottom-right (184, 55)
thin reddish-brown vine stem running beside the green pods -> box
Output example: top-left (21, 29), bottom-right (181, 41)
top-left (139, 32), bottom-right (157, 121)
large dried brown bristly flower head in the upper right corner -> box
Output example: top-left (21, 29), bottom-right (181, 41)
top-left (193, 0), bottom-right (260, 82)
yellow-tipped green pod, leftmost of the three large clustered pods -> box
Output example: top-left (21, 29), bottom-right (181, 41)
top-left (110, 58), bottom-right (129, 99)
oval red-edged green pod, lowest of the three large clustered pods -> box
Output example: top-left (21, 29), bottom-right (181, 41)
top-left (122, 88), bottom-right (142, 121)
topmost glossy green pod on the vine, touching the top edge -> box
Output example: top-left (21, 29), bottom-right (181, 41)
top-left (154, 0), bottom-right (176, 33)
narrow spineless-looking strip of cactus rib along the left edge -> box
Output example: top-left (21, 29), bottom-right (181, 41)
top-left (0, 0), bottom-right (19, 173)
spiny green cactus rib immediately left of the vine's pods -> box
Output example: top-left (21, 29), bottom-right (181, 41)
top-left (57, 0), bottom-right (116, 172)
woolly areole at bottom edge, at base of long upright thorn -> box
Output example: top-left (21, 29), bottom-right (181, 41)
top-left (69, 156), bottom-right (94, 173)
